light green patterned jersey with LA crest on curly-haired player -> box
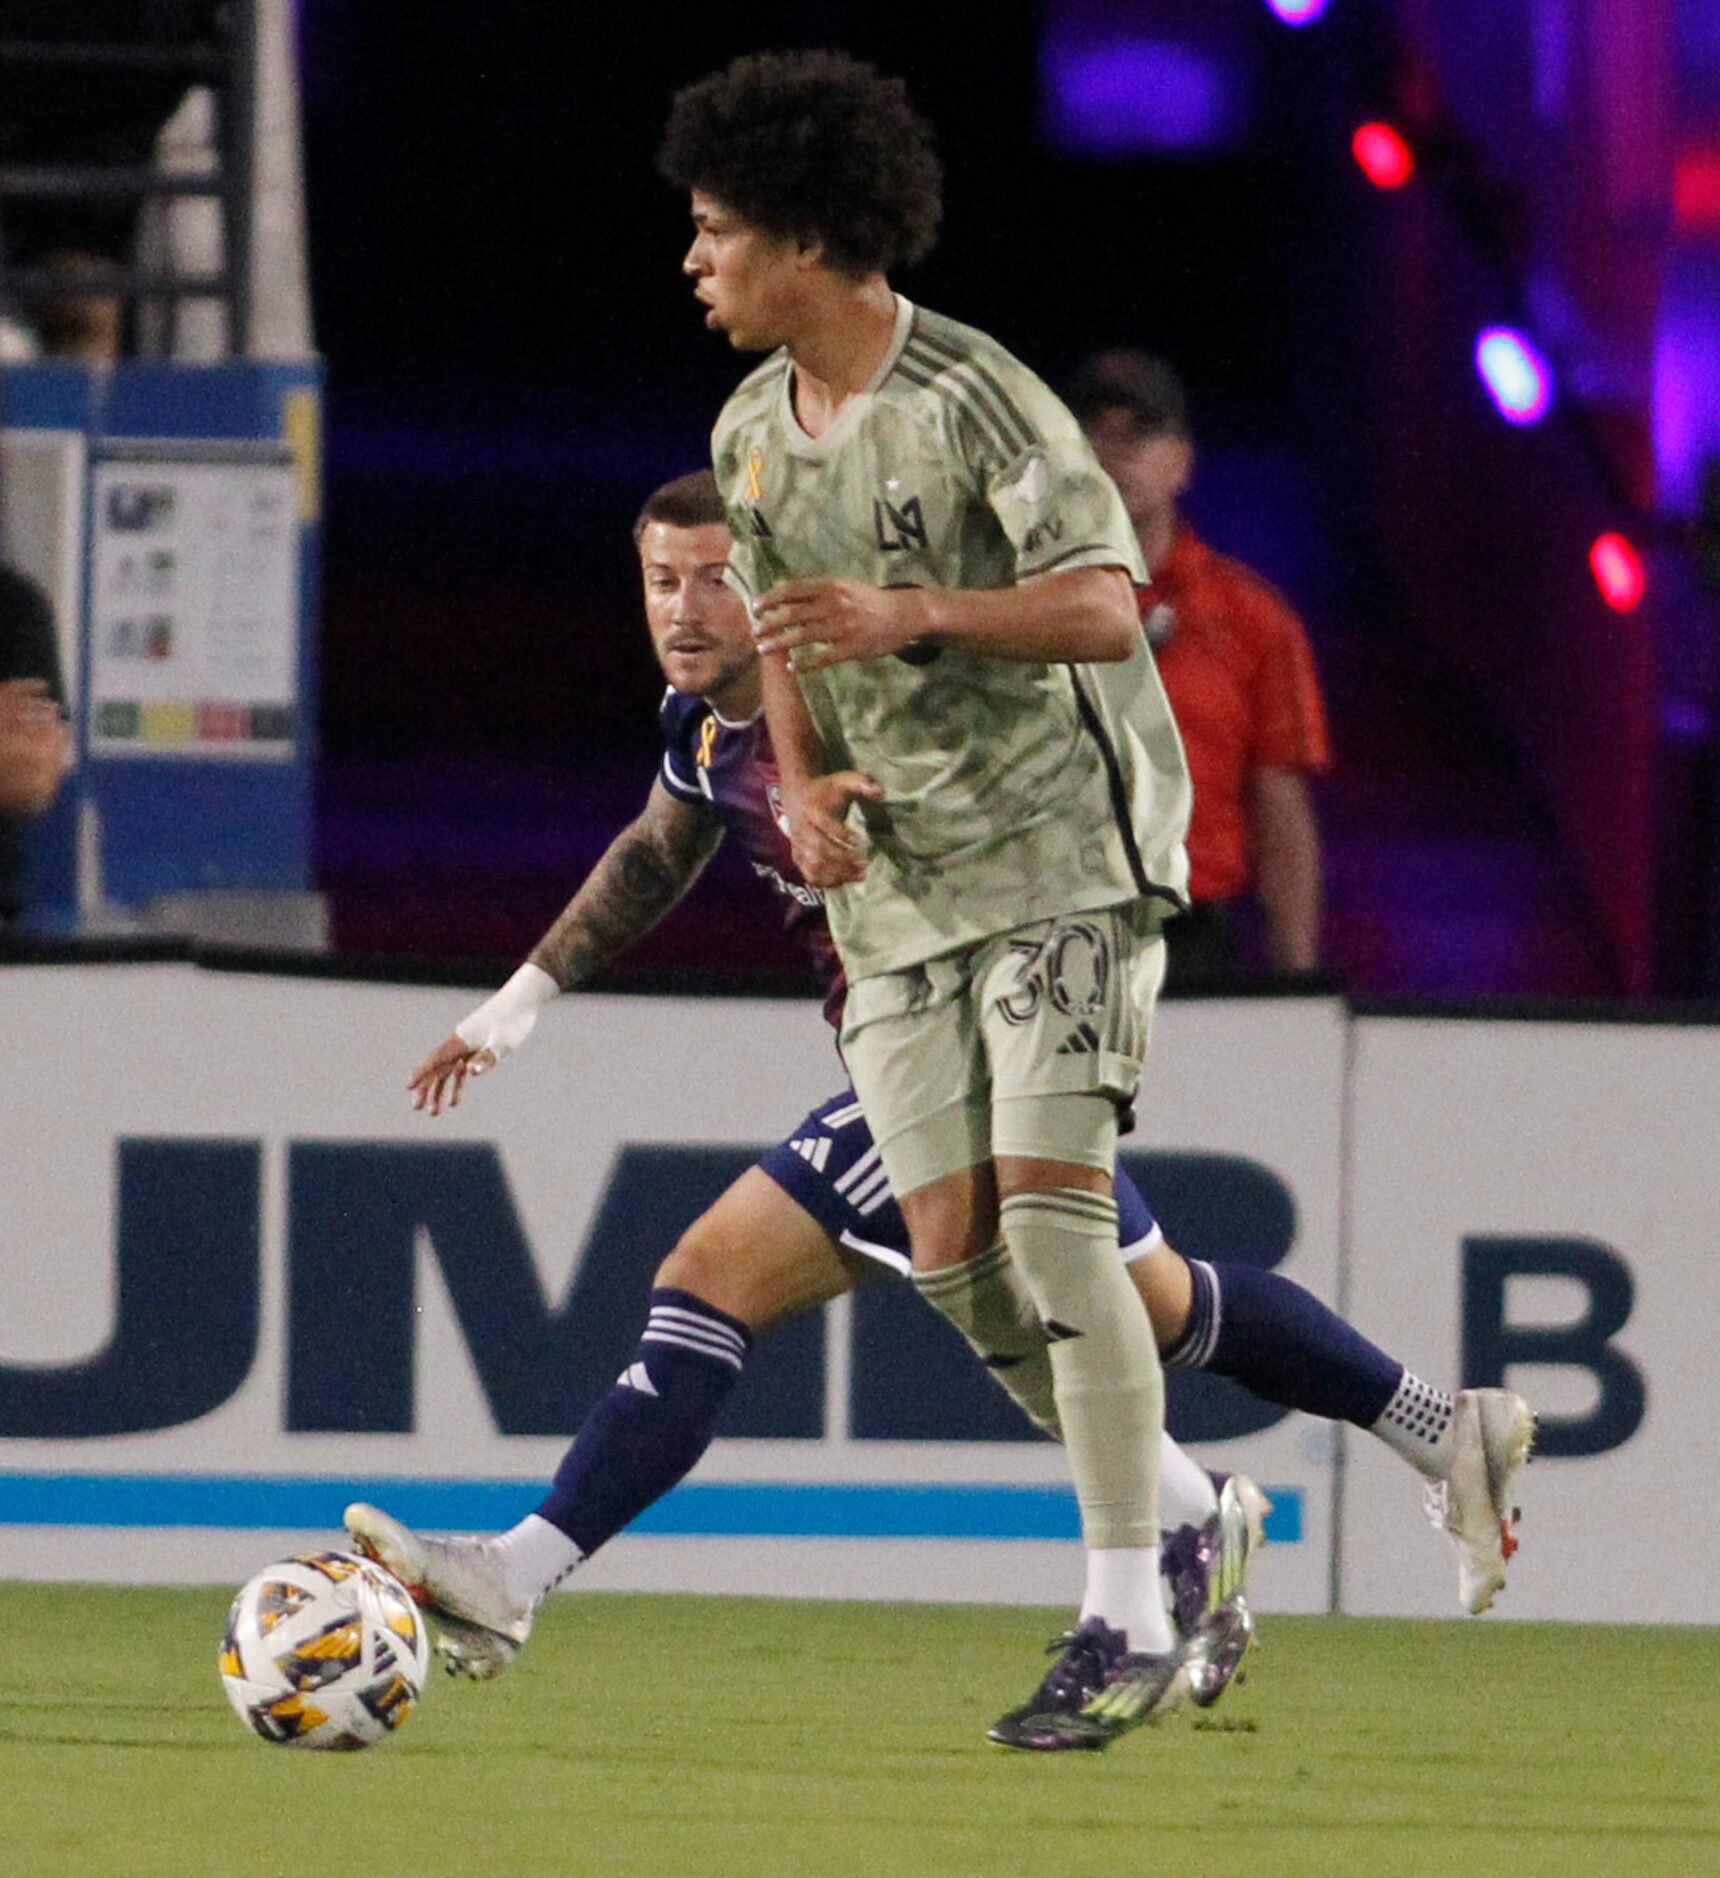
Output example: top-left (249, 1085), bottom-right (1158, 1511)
top-left (712, 297), bottom-right (1189, 978)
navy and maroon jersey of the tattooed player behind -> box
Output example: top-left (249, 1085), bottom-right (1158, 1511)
top-left (657, 689), bottom-right (847, 1024)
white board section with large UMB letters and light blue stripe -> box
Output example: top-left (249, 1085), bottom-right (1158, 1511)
top-left (0, 965), bottom-right (1344, 1609)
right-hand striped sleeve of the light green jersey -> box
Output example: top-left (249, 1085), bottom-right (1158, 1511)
top-left (958, 357), bottom-right (1147, 584)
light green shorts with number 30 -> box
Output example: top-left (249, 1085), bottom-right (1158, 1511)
top-left (841, 907), bottom-right (1164, 1196)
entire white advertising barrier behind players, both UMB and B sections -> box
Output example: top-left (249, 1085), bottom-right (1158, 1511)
top-left (23, 965), bottom-right (1720, 1623)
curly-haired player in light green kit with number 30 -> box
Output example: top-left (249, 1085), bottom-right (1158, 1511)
top-left (661, 53), bottom-right (1189, 1748)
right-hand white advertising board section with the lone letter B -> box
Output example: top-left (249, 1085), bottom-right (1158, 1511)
top-left (1343, 1018), bottom-right (1720, 1623)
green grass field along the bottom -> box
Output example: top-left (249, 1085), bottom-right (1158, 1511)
top-left (0, 1585), bottom-right (1720, 1878)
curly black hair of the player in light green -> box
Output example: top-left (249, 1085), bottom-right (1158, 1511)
top-left (657, 53), bottom-right (943, 278)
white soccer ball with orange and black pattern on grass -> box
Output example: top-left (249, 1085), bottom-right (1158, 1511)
top-left (220, 1551), bottom-right (430, 1748)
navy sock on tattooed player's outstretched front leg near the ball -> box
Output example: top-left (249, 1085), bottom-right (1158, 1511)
top-left (537, 1286), bottom-right (753, 1559)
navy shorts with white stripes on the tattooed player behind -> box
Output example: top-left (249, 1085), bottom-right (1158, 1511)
top-left (759, 1089), bottom-right (1162, 1271)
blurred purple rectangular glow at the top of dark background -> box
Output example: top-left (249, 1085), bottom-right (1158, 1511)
top-left (1040, 38), bottom-right (1245, 156)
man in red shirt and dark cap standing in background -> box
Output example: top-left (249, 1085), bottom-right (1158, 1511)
top-left (1065, 351), bottom-right (1329, 984)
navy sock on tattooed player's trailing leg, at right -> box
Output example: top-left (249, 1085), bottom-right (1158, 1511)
top-left (1164, 1258), bottom-right (1403, 1427)
